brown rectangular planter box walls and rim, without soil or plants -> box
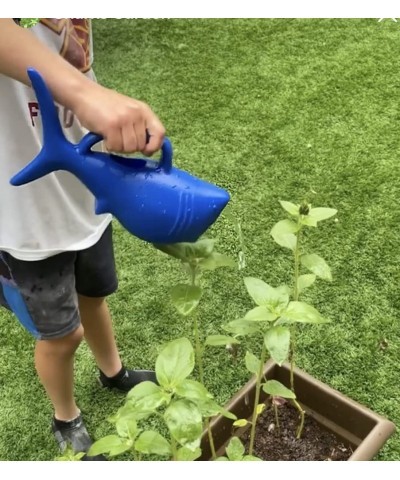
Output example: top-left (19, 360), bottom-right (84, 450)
top-left (199, 361), bottom-right (396, 461)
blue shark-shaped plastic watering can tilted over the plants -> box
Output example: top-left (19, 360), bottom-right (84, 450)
top-left (10, 69), bottom-right (230, 244)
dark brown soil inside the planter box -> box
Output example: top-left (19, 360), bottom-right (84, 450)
top-left (242, 403), bottom-right (353, 461)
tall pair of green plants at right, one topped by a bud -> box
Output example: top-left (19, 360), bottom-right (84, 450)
top-left (220, 201), bottom-right (336, 455)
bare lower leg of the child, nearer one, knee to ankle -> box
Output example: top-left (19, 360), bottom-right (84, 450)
top-left (35, 325), bottom-right (83, 421)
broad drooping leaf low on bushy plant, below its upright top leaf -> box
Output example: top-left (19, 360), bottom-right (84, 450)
top-left (164, 399), bottom-right (203, 450)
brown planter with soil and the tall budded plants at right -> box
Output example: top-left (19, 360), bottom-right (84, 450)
top-left (200, 202), bottom-right (395, 461)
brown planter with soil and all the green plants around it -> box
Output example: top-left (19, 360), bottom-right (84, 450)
top-left (89, 202), bottom-right (395, 461)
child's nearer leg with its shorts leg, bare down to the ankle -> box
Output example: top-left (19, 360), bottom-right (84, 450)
top-left (0, 252), bottom-right (83, 420)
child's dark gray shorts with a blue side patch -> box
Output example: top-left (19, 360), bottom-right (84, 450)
top-left (0, 224), bottom-right (118, 340)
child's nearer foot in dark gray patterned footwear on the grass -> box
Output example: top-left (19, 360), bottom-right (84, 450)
top-left (51, 414), bottom-right (107, 461)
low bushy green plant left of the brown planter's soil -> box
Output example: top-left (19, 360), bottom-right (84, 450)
top-left (88, 338), bottom-right (236, 460)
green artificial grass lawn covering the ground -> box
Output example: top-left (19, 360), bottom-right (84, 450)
top-left (0, 19), bottom-right (400, 460)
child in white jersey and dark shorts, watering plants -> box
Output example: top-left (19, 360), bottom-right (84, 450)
top-left (0, 18), bottom-right (165, 460)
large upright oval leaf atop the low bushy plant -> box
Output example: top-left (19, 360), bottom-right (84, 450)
top-left (156, 338), bottom-right (194, 390)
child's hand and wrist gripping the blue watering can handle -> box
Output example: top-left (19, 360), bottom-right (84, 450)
top-left (72, 82), bottom-right (165, 155)
